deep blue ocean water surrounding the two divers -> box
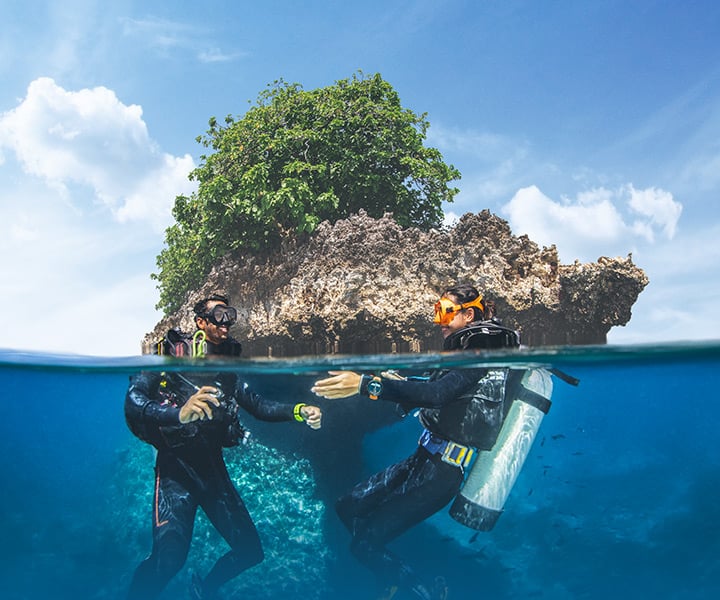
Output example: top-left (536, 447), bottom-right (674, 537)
top-left (0, 342), bottom-right (720, 600)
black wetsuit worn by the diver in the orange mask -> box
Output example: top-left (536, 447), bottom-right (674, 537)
top-left (336, 369), bottom-right (507, 598)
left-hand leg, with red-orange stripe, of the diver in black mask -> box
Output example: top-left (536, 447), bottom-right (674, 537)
top-left (128, 457), bottom-right (197, 600)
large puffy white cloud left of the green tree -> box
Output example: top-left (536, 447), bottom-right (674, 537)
top-left (0, 77), bottom-right (195, 231)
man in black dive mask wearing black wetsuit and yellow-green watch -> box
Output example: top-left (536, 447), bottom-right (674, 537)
top-left (125, 294), bottom-right (322, 600)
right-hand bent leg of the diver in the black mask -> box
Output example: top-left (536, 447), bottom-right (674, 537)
top-left (191, 464), bottom-right (265, 598)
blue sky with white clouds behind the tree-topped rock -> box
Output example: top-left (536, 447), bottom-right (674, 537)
top-left (0, 0), bottom-right (720, 356)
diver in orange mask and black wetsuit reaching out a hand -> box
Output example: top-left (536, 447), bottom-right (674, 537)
top-left (312, 285), bottom-right (519, 600)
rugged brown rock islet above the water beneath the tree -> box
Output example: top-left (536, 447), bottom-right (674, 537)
top-left (143, 210), bottom-right (648, 356)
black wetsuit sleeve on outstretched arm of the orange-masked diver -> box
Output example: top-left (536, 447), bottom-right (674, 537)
top-left (360, 369), bottom-right (487, 409)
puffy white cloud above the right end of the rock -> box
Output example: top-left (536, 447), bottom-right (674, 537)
top-left (502, 185), bottom-right (682, 262)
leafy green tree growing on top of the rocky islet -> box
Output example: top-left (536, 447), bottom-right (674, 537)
top-left (153, 74), bottom-right (460, 313)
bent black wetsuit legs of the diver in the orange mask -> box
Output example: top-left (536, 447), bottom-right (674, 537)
top-left (337, 449), bottom-right (462, 598)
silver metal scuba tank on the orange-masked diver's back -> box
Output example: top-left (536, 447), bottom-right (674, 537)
top-left (450, 369), bottom-right (553, 531)
